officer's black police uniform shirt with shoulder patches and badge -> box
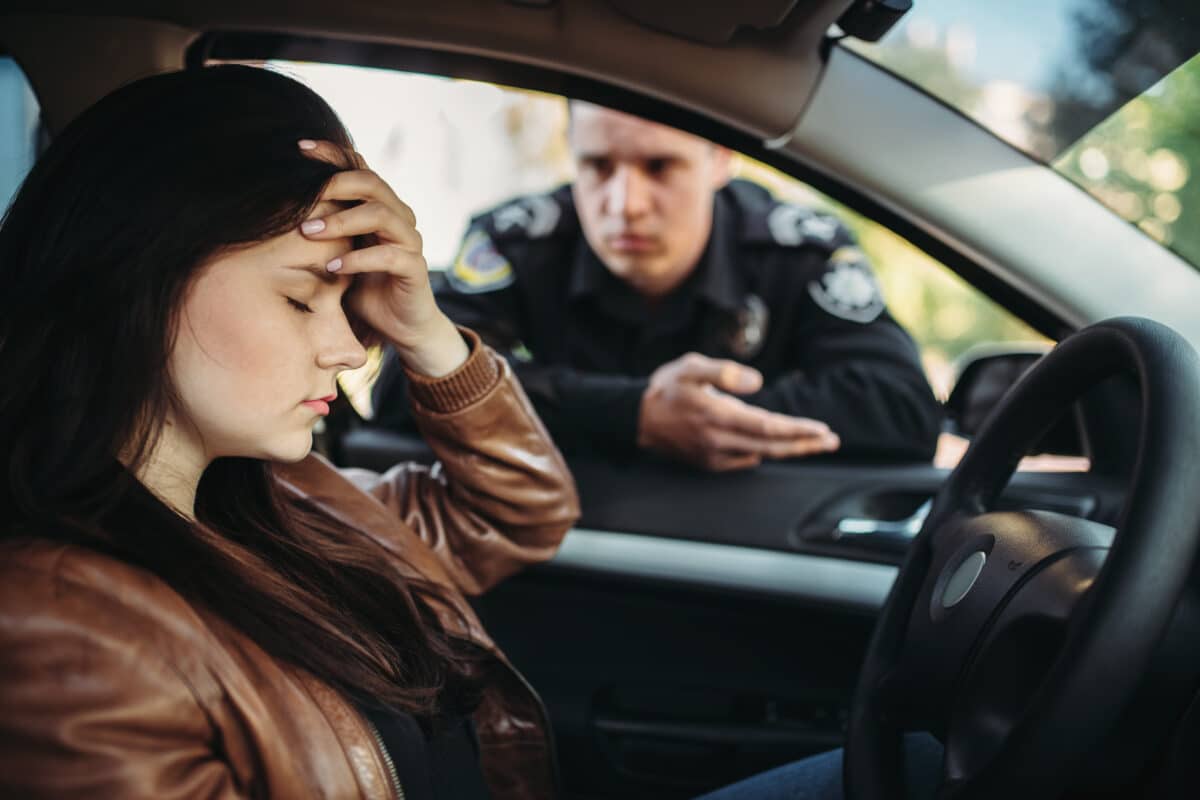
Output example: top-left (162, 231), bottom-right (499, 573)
top-left (373, 180), bottom-right (941, 459)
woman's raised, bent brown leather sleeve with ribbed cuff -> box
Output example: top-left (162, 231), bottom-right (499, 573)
top-left (343, 329), bottom-right (580, 594)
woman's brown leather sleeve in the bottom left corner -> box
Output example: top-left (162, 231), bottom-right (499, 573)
top-left (0, 554), bottom-right (250, 800)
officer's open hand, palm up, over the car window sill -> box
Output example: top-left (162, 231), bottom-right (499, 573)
top-left (637, 353), bottom-right (840, 471)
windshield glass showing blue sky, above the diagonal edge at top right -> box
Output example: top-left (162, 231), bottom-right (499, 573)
top-left (844, 0), bottom-right (1200, 162)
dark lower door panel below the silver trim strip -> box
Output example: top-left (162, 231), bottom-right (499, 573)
top-left (475, 564), bottom-right (872, 798)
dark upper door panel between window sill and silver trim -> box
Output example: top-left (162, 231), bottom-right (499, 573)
top-left (338, 427), bottom-right (1126, 564)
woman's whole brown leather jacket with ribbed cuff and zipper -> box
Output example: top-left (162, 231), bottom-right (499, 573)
top-left (0, 335), bottom-right (578, 800)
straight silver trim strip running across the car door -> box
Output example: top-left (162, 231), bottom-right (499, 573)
top-left (549, 528), bottom-right (898, 613)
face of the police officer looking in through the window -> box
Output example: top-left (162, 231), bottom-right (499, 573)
top-left (570, 102), bottom-right (730, 296)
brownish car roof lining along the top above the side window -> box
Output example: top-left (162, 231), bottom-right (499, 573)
top-left (0, 0), bottom-right (853, 139)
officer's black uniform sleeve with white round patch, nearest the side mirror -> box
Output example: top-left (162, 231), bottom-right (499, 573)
top-left (746, 247), bottom-right (942, 461)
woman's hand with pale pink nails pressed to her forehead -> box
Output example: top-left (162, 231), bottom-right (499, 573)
top-left (299, 139), bottom-right (469, 378)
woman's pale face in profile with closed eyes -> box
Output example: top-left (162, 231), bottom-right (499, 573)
top-left (169, 203), bottom-right (366, 462)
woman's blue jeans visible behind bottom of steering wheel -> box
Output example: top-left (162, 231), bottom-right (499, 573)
top-left (697, 733), bottom-right (942, 800)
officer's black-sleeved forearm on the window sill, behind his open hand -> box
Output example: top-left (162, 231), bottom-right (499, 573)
top-left (743, 361), bottom-right (942, 461)
